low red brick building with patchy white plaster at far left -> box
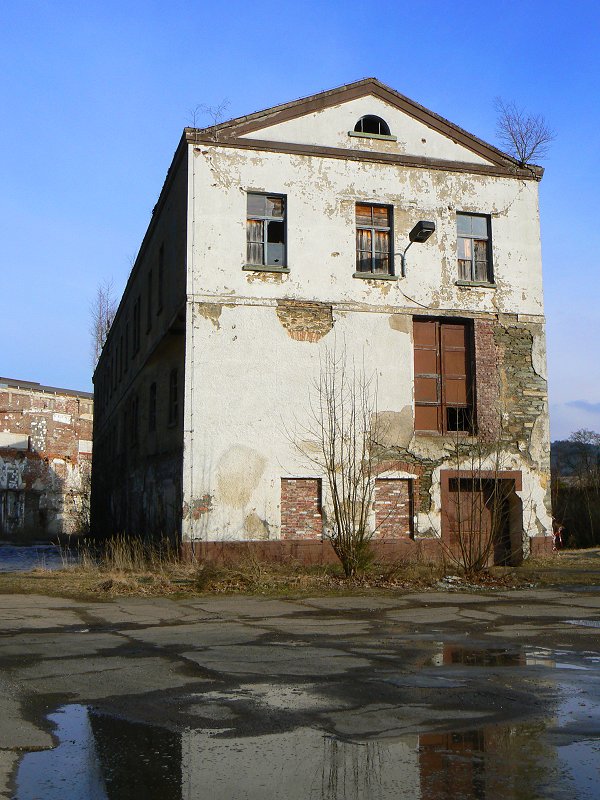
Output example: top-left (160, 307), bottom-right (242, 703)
top-left (0, 378), bottom-right (94, 539)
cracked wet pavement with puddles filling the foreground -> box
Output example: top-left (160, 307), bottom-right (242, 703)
top-left (0, 586), bottom-right (600, 800)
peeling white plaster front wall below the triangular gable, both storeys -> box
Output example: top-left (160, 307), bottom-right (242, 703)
top-left (182, 139), bottom-right (550, 552)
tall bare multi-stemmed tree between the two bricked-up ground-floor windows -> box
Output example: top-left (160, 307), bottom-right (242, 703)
top-left (290, 349), bottom-right (377, 577)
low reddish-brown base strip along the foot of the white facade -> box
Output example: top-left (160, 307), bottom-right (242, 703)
top-left (181, 536), bottom-right (552, 566)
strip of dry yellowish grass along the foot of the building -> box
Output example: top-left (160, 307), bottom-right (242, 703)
top-left (0, 537), bottom-right (600, 600)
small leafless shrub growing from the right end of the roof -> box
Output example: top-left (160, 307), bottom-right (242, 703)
top-left (495, 97), bottom-right (556, 167)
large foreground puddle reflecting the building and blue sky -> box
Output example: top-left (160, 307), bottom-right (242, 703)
top-left (15, 705), bottom-right (599, 800)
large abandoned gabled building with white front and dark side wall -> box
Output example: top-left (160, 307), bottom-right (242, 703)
top-left (92, 79), bottom-right (551, 563)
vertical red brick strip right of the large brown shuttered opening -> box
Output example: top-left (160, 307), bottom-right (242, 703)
top-left (474, 319), bottom-right (501, 441)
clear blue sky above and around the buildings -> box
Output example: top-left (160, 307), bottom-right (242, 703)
top-left (0, 0), bottom-right (600, 438)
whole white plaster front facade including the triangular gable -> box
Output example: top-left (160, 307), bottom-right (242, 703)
top-left (92, 79), bottom-right (550, 560)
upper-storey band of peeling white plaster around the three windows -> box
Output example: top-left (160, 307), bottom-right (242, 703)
top-left (188, 144), bottom-right (543, 316)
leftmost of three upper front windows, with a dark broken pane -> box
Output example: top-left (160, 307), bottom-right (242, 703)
top-left (246, 194), bottom-right (286, 268)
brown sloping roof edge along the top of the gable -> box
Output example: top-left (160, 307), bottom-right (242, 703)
top-left (186, 78), bottom-right (544, 180)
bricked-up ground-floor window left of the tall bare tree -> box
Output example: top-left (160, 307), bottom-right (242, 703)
top-left (281, 478), bottom-right (323, 539)
